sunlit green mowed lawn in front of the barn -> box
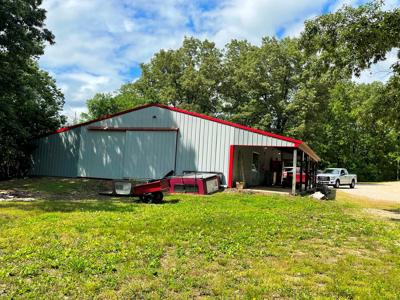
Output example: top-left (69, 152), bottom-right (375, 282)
top-left (0, 179), bottom-right (400, 299)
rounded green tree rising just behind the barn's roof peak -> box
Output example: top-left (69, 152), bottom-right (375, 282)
top-left (134, 38), bottom-right (222, 114)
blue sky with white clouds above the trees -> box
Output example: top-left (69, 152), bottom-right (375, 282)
top-left (40, 0), bottom-right (400, 117)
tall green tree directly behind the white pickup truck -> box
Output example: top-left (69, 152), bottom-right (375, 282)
top-left (318, 81), bottom-right (397, 180)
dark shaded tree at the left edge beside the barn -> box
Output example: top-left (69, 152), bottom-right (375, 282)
top-left (0, 0), bottom-right (65, 178)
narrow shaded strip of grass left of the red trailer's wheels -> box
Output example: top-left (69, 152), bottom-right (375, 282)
top-left (0, 198), bottom-right (179, 213)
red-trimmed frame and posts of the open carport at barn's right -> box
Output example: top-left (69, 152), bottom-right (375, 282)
top-left (227, 140), bottom-right (321, 195)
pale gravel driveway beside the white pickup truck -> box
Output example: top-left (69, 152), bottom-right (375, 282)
top-left (340, 181), bottom-right (400, 203)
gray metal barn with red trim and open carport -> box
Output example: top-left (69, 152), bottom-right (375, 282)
top-left (31, 104), bottom-right (319, 195)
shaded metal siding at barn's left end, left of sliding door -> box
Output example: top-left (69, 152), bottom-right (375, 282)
top-left (30, 128), bottom-right (81, 177)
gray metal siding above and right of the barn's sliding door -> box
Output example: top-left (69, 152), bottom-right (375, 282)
top-left (91, 107), bottom-right (294, 183)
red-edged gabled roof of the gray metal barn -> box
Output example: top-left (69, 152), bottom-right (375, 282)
top-left (52, 103), bottom-right (321, 161)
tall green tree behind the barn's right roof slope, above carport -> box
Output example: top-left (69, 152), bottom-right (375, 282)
top-left (222, 38), bottom-right (303, 133)
